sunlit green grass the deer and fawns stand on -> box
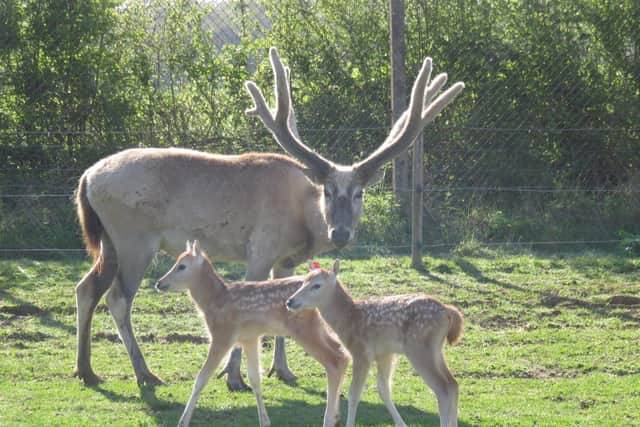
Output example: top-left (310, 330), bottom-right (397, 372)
top-left (0, 252), bottom-right (640, 426)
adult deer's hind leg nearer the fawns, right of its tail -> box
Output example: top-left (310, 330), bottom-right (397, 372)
top-left (107, 236), bottom-right (163, 385)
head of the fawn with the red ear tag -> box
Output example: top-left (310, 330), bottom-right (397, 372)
top-left (287, 260), bottom-right (340, 311)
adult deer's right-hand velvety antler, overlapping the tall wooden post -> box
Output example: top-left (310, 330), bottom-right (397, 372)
top-left (353, 58), bottom-right (464, 182)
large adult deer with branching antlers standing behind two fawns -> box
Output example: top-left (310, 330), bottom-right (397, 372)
top-left (76, 48), bottom-right (464, 389)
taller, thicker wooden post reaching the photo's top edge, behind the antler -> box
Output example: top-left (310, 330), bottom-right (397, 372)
top-left (389, 0), bottom-right (409, 215)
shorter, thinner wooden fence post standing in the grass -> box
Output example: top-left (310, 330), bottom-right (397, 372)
top-left (411, 133), bottom-right (424, 270)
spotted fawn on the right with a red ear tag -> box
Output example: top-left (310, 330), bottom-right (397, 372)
top-left (287, 260), bottom-right (464, 427)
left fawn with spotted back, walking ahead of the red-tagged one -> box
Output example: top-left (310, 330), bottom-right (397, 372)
top-left (156, 240), bottom-right (348, 427)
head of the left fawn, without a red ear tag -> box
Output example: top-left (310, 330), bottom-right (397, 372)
top-left (155, 240), bottom-right (209, 292)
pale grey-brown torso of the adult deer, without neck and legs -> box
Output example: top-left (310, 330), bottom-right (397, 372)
top-left (85, 148), bottom-right (316, 260)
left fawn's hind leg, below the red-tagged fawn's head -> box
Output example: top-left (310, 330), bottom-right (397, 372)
top-left (290, 311), bottom-right (349, 427)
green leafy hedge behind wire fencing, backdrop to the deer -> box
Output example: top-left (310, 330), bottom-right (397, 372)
top-left (0, 0), bottom-right (640, 256)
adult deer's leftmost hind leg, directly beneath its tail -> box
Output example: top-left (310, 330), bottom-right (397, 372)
top-left (75, 236), bottom-right (118, 385)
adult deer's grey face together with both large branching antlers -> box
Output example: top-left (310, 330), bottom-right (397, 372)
top-left (245, 47), bottom-right (464, 247)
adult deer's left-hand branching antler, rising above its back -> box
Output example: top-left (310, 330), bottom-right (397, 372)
top-left (245, 47), bottom-right (334, 178)
